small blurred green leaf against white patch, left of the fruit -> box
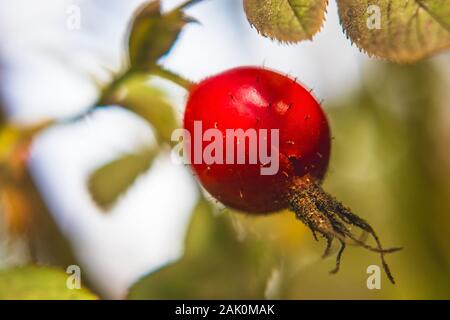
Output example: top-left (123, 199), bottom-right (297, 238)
top-left (88, 147), bottom-right (158, 210)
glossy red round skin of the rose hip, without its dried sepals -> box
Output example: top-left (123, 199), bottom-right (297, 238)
top-left (184, 67), bottom-right (330, 213)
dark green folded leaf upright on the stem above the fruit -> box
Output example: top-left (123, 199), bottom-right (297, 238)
top-left (128, 0), bottom-right (194, 71)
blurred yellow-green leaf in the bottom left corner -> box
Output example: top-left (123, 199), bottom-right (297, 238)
top-left (0, 266), bottom-right (97, 300)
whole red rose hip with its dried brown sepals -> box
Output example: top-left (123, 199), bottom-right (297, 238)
top-left (184, 67), bottom-right (399, 282)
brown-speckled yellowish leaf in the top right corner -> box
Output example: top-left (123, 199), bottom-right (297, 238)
top-left (337, 0), bottom-right (450, 63)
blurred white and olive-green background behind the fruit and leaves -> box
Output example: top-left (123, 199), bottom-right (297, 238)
top-left (0, 0), bottom-right (450, 299)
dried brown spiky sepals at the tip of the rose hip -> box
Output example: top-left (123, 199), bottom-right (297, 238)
top-left (288, 177), bottom-right (402, 283)
